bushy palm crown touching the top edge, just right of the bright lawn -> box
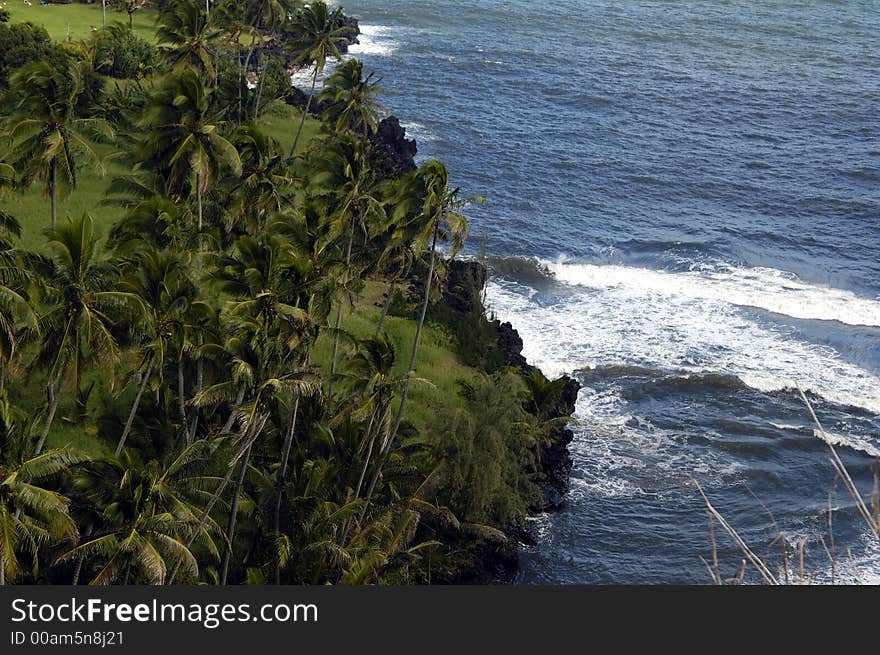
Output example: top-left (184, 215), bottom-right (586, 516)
top-left (156, 0), bottom-right (221, 85)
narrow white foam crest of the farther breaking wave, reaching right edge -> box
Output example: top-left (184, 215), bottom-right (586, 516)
top-left (545, 260), bottom-right (880, 326)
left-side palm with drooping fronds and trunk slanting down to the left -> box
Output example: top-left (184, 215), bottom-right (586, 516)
top-left (34, 214), bottom-right (143, 455)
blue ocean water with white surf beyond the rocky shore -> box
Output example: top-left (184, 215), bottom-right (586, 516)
top-left (332, 0), bottom-right (880, 583)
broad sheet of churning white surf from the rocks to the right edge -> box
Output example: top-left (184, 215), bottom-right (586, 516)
top-left (487, 263), bottom-right (880, 414)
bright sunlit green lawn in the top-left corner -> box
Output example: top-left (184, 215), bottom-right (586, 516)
top-left (6, 0), bottom-right (156, 43)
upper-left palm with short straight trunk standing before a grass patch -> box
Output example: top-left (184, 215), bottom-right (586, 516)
top-left (4, 61), bottom-right (114, 229)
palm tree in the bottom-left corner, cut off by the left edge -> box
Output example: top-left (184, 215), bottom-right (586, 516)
top-left (0, 400), bottom-right (87, 586)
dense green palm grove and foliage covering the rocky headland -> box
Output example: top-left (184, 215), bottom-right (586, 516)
top-left (0, 0), bottom-right (568, 584)
